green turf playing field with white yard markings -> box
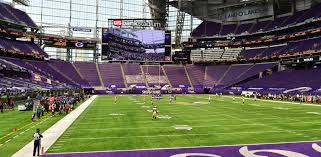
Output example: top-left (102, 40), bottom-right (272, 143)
top-left (48, 95), bottom-right (321, 153)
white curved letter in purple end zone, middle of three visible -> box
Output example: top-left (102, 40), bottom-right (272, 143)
top-left (239, 146), bottom-right (309, 157)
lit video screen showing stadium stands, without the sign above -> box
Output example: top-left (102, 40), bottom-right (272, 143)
top-left (102, 28), bottom-right (165, 61)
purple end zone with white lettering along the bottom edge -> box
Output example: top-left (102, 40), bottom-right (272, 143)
top-left (45, 141), bottom-right (321, 157)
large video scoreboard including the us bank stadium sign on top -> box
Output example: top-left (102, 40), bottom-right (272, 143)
top-left (101, 19), bottom-right (171, 61)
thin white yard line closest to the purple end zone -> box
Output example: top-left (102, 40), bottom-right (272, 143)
top-left (60, 129), bottom-right (321, 140)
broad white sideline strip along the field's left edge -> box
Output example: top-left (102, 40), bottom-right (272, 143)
top-left (13, 95), bottom-right (97, 157)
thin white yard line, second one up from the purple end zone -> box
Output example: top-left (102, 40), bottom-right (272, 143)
top-left (69, 122), bottom-right (321, 131)
